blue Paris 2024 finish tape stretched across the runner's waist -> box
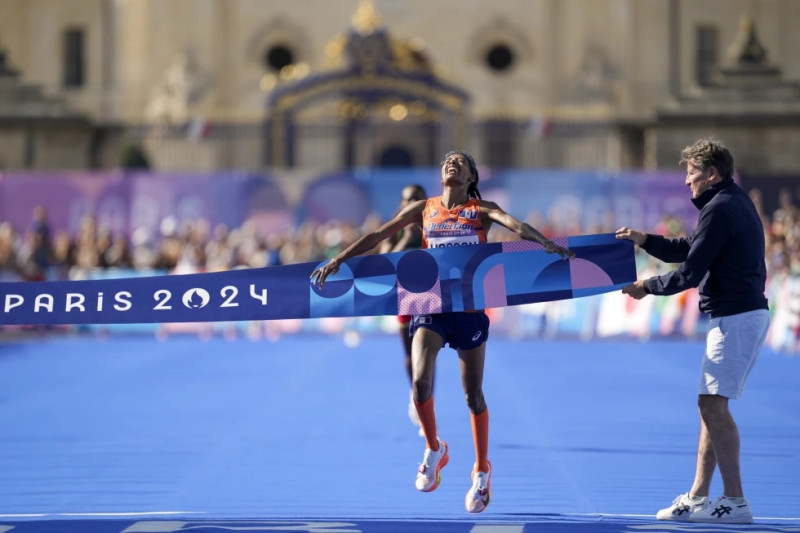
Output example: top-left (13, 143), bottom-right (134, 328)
top-left (0, 234), bottom-right (636, 325)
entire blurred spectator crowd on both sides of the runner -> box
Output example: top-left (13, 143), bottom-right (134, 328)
top-left (0, 189), bottom-right (800, 352)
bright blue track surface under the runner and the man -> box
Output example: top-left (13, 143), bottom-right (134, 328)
top-left (0, 336), bottom-right (800, 533)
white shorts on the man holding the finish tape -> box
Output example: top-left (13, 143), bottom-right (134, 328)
top-left (700, 309), bottom-right (769, 400)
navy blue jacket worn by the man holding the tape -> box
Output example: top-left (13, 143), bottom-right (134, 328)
top-left (642, 181), bottom-right (767, 317)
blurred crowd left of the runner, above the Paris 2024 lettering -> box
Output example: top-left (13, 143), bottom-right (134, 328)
top-left (0, 206), bottom-right (380, 281)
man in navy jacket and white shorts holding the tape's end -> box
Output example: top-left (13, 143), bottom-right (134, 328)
top-left (616, 139), bottom-right (769, 524)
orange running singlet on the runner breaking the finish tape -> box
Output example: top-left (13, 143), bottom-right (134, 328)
top-left (422, 196), bottom-right (486, 248)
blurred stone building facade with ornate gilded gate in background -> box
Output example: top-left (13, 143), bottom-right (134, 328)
top-left (0, 0), bottom-right (800, 173)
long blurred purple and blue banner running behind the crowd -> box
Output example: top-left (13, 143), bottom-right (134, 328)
top-left (0, 168), bottom-right (697, 237)
